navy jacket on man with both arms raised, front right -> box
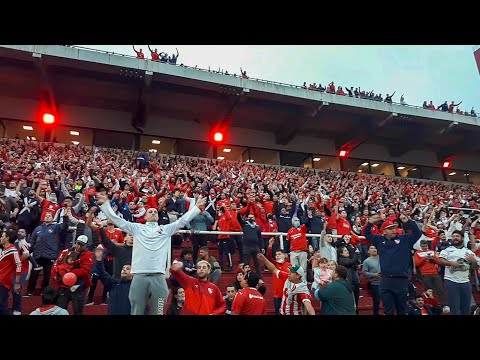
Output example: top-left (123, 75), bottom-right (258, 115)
top-left (365, 220), bottom-right (422, 278)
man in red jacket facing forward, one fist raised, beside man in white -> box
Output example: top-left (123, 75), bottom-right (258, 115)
top-left (170, 260), bottom-right (227, 315)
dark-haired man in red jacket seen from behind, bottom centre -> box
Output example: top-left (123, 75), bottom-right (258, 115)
top-left (231, 271), bottom-right (267, 315)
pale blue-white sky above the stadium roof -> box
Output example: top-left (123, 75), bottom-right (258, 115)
top-left (82, 44), bottom-right (480, 113)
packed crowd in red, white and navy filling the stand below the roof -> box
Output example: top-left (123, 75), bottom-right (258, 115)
top-left (0, 139), bottom-right (480, 315)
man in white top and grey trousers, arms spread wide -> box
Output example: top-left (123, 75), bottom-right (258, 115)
top-left (96, 194), bottom-right (205, 315)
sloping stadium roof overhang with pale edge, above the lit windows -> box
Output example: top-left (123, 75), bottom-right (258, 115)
top-left (0, 45), bottom-right (480, 157)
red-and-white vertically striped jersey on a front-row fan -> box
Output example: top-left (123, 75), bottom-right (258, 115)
top-left (277, 271), bottom-right (312, 315)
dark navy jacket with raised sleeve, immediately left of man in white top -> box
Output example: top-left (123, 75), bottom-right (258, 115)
top-left (95, 259), bottom-right (132, 315)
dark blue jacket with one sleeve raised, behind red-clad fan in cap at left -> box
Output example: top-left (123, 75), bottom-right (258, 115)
top-left (30, 216), bottom-right (69, 260)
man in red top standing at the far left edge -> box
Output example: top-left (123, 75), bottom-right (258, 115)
top-left (0, 229), bottom-right (22, 315)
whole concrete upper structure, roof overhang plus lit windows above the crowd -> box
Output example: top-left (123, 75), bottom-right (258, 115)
top-left (0, 45), bottom-right (480, 184)
